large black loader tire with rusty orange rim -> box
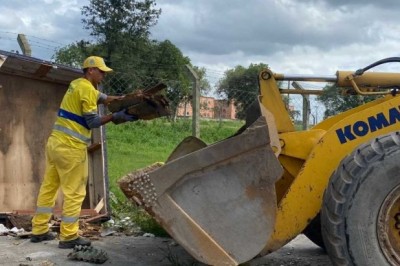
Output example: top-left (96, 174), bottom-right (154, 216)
top-left (321, 132), bottom-right (400, 266)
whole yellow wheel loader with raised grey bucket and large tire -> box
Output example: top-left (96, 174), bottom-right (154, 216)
top-left (119, 57), bottom-right (400, 266)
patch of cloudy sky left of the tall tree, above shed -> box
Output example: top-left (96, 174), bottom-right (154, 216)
top-left (0, 0), bottom-right (89, 59)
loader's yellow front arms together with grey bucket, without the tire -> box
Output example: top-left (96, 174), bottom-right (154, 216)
top-left (120, 58), bottom-right (400, 265)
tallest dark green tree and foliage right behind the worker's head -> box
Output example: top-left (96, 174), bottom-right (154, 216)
top-left (56, 0), bottom-right (210, 121)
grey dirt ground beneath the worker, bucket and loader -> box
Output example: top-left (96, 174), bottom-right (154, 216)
top-left (0, 235), bottom-right (332, 266)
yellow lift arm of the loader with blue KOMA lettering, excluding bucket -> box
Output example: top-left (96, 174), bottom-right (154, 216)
top-left (259, 70), bottom-right (400, 255)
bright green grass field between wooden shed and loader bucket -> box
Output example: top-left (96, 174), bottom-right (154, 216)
top-left (106, 119), bottom-right (244, 235)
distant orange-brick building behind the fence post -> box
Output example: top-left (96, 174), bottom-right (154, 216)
top-left (177, 96), bottom-right (236, 120)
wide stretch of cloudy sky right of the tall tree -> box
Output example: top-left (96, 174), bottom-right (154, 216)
top-left (148, 0), bottom-right (400, 83)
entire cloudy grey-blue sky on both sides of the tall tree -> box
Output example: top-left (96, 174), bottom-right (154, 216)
top-left (0, 0), bottom-right (400, 85)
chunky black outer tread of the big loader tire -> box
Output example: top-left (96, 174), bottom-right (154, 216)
top-left (321, 132), bottom-right (400, 266)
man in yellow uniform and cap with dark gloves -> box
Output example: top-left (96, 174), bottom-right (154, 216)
top-left (31, 56), bottom-right (137, 248)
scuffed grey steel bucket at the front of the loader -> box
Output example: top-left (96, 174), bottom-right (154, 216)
top-left (119, 117), bottom-right (282, 265)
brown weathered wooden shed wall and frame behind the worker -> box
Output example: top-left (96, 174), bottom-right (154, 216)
top-left (0, 50), bottom-right (109, 214)
